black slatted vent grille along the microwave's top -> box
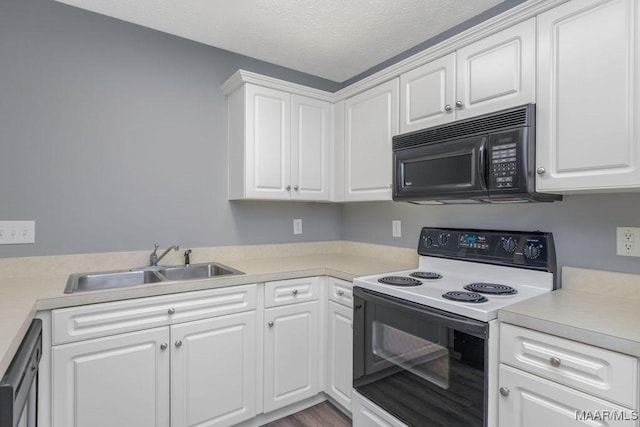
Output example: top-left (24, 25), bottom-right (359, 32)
top-left (393, 104), bottom-right (533, 150)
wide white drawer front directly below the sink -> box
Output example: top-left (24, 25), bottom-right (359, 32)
top-left (51, 284), bottom-right (257, 345)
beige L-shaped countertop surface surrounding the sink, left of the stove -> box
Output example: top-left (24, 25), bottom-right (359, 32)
top-left (0, 253), bottom-right (417, 377)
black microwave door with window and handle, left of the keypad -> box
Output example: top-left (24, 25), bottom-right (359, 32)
top-left (393, 136), bottom-right (488, 200)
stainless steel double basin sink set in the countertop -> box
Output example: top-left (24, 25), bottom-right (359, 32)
top-left (64, 262), bottom-right (244, 294)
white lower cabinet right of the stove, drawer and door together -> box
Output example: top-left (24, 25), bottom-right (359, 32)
top-left (495, 323), bottom-right (638, 427)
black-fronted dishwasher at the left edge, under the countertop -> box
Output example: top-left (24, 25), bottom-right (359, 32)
top-left (0, 319), bottom-right (42, 427)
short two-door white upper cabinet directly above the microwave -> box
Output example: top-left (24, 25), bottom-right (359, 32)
top-left (400, 18), bottom-right (536, 133)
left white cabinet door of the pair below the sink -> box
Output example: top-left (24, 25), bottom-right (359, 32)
top-left (52, 327), bottom-right (169, 427)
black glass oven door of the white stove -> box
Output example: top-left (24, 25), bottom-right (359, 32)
top-left (353, 287), bottom-right (489, 427)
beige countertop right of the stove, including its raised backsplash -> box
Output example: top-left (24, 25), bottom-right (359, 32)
top-left (498, 267), bottom-right (640, 357)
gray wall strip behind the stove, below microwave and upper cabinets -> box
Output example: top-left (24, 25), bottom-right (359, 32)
top-left (342, 193), bottom-right (640, 273)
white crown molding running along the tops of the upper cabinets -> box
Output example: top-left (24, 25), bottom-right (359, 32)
top-left (221, 0), bottom-right (569, 103)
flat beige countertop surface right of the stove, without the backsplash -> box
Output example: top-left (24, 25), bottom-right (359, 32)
top-left (498, 290), bottom-right (640, 357)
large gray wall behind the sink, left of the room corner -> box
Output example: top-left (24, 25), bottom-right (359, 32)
top-left (0, 0), bottom-right (342, 257)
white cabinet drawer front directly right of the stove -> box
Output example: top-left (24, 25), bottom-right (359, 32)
top-left (500, 323), bottom-right (638, 408)
